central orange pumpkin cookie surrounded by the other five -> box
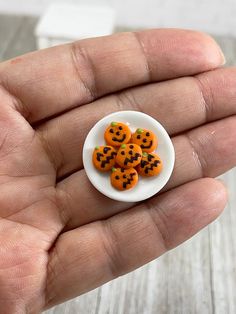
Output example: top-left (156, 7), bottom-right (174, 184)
top-left (116, 144), bottom-right (142, 169)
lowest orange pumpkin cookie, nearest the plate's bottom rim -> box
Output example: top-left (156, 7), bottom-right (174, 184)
top-left (111, 168), bottom-right (138, 191)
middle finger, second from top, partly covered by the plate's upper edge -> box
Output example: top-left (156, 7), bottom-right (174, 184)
top-left (37, 68), bottom-right (236, 180)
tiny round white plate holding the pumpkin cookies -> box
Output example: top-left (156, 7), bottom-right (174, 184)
top-left (83, 111), bottom-right (175, 202)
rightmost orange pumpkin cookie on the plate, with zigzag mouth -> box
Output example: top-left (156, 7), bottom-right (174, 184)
top-left (137, 152), bottom-right (162, 177)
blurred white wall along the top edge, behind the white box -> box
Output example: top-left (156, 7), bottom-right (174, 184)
top-left (0, 0), bottom-right (236, 35)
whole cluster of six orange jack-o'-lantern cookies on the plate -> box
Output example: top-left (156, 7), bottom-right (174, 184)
top-left (92, 122), bottom-right (163, 191)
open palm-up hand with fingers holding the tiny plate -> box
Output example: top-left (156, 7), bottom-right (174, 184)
top-left (0, 30), bottom-right (236, 314)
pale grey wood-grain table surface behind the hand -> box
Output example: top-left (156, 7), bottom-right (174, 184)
top-left (0, 15), bottom-right (236, 314)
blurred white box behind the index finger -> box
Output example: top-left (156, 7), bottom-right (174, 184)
top-left (35, 3), bottom-right (115, 49)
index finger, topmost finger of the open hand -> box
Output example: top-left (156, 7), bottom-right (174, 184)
top-left (0, 29), bottom-right (224, 123)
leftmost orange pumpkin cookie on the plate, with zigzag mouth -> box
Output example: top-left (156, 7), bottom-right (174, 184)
top-left (93, 146), bottom-right (117, 171)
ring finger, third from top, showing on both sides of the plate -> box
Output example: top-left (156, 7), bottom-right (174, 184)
top-left (57, 116), bottom-right (236, 229)
